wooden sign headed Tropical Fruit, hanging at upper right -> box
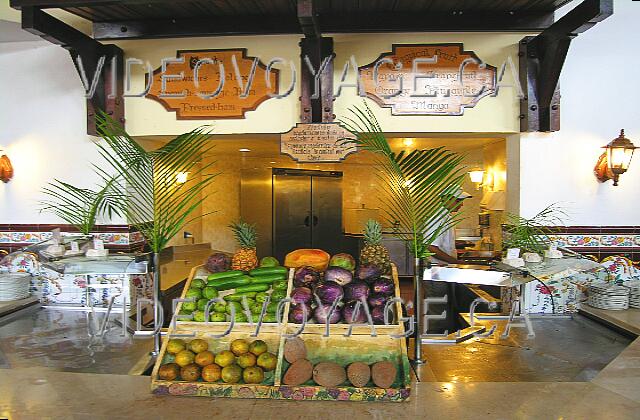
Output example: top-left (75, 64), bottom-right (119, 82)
top-left (359, 44), bottom-right (496, 115)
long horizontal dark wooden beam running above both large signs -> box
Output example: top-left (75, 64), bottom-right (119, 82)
top-left (93, 13), bottom-right (553, 40)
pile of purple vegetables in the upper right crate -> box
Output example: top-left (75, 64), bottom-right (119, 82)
top-left (288, 253), bottom-right (397, 325)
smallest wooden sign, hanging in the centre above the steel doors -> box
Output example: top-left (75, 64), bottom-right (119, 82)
top-left (280, 123), bottom-right (357, 162)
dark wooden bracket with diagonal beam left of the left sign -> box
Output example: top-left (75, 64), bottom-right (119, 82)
top-left (22, 6), bottom-right (124, 135)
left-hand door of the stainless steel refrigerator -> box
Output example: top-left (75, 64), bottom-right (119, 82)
top-left (273, 174), bottom-right (312, 263)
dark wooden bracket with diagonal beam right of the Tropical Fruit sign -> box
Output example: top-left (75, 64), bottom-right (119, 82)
top-left (519, 0), bottom-right (613, 131)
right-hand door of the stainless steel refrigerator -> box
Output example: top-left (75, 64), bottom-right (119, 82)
top-left (311, 175), bottom-right (342, 255)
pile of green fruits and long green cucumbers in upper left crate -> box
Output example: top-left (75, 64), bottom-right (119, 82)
top-left (178, 254), bottom-right (288, 324)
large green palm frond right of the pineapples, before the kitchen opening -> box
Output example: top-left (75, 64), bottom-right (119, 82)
top-left (341, 103), bottom-right (464, 258)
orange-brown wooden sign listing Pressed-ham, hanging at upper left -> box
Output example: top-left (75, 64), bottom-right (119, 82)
top-left (146, 48), bottom-right (279, 120)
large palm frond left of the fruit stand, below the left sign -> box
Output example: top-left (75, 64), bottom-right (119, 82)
top-left (96, 113), bottom-right (217, 252)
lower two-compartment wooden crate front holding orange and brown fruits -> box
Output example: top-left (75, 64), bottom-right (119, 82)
top-left (151, 332), bottom-right (411, 402)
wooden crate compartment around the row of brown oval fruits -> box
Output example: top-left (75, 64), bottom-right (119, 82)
top-left (271, 334), bottom-right (411, 402)
